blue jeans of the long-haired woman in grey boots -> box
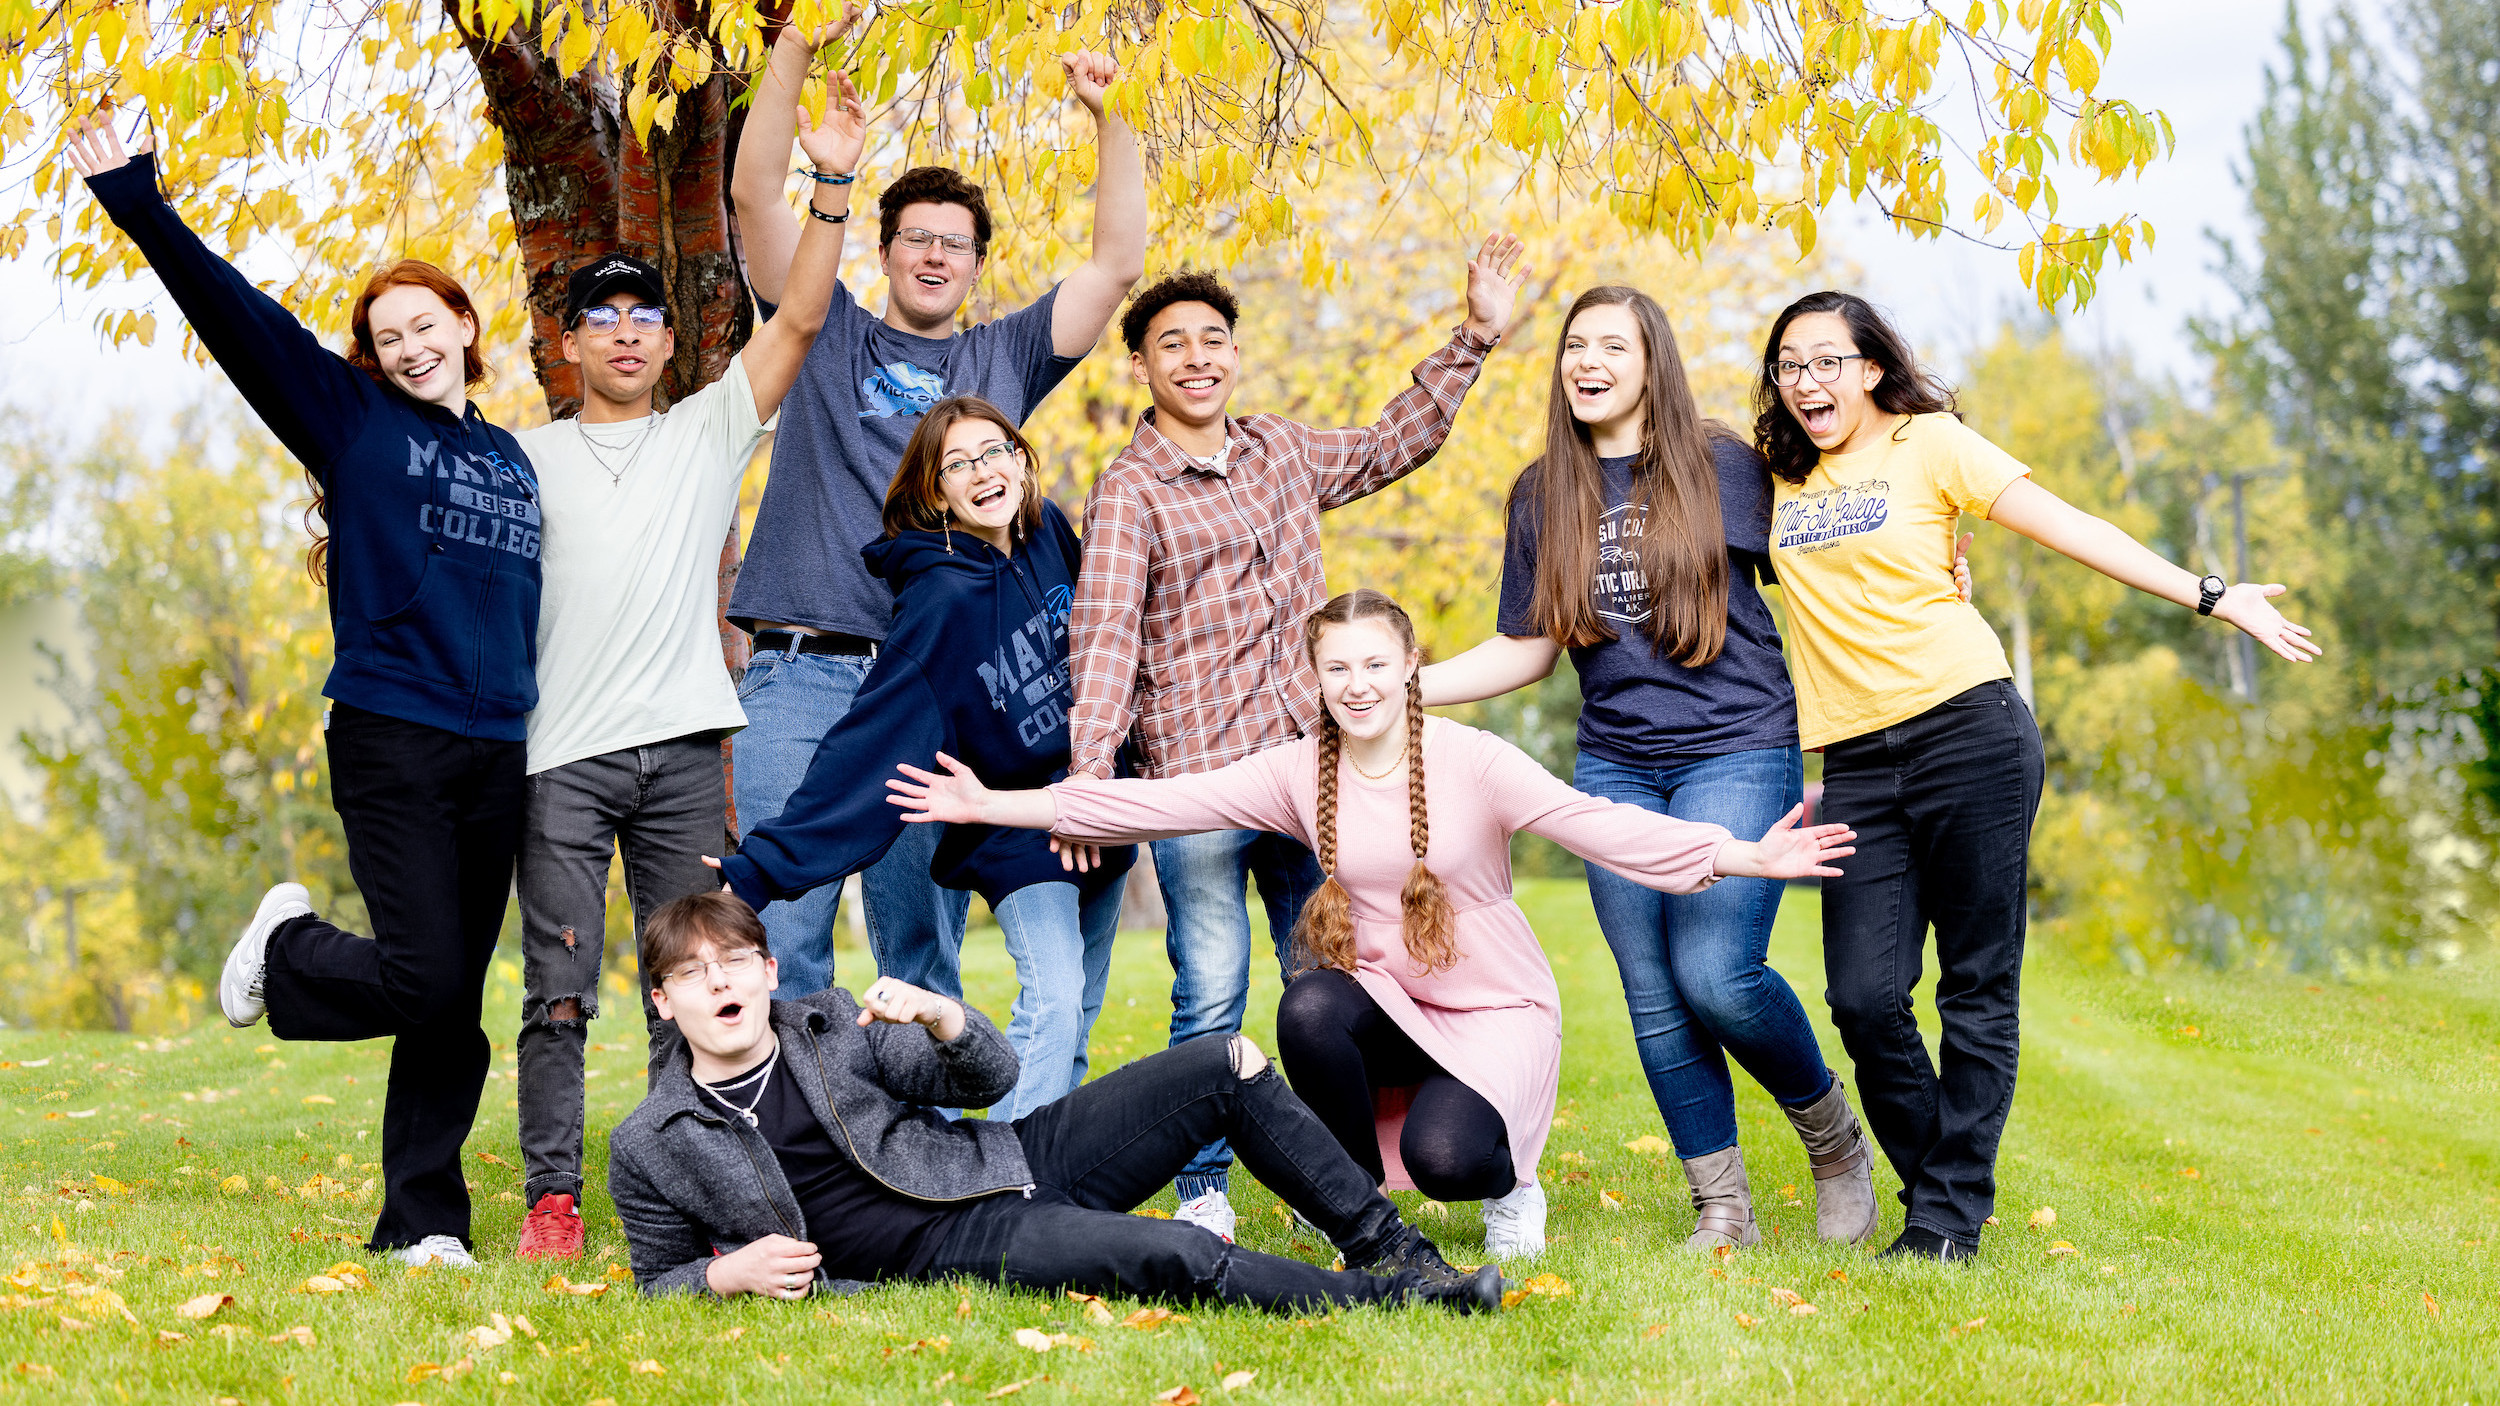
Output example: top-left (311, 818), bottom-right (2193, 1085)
top-left (1573, 748), bottom-right (1833, 1158)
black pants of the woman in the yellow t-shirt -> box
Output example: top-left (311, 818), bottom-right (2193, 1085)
top-left (1818, 680), bottom-right (2040, 1243)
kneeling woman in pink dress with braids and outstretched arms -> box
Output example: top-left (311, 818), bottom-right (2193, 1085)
top-left (888, 590), bottom-right (1853, 1258)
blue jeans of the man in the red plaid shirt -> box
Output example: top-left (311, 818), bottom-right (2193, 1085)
top-left (1155, 831), bottom-right (1325, 1185)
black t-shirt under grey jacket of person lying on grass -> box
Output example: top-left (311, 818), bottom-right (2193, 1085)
top-left (708, 1045), bottom-right (958, 1278)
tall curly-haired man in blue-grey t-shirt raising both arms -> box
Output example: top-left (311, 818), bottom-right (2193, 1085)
top-left (728, 30), bottom-right (1148, 996)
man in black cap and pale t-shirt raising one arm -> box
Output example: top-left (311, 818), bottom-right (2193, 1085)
top-left (502, 80), bottom-right (868, 1258)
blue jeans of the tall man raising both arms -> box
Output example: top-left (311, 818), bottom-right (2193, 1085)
top-left (730, 650), bottom-right (973, 1001)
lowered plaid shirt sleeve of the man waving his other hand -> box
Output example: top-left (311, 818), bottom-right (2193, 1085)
top-left (1068, 480), bottom-right (1155, 778)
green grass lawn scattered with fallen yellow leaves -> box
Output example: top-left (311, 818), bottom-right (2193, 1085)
top-left (0, 881), bottom-right (2500, 1406)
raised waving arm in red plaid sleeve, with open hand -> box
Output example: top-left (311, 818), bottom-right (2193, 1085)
top-left (1305, 235), bottom-right (1528, 513)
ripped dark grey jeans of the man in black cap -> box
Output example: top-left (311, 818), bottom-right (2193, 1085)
top-left (513, 733), bottom-right (730, 1206)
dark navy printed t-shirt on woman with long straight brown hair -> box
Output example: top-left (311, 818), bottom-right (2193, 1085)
top-left (1495, 435), bottom-right (1798, 768)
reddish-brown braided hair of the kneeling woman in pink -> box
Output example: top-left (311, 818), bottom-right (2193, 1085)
top-left (1293, 590), bottom-right (1463, 976)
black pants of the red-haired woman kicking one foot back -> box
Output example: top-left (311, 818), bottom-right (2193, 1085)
top-left (263, 703), bottom-right (523, 1251)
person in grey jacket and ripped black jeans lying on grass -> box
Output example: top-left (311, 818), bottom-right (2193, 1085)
top-left (608, 893), bottom-right (1503, 1311)
